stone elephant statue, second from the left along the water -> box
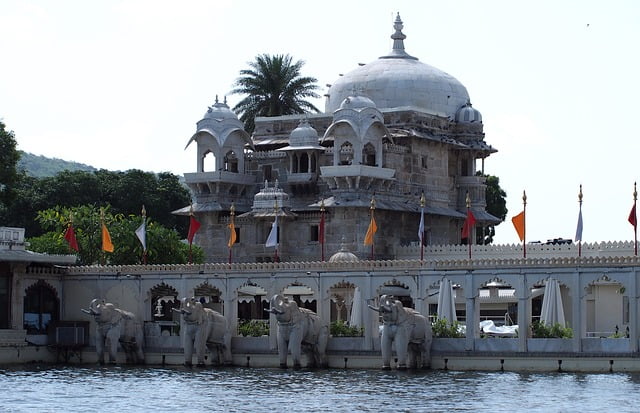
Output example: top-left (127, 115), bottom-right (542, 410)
top-left (174, 297), bottom-right (231, 366)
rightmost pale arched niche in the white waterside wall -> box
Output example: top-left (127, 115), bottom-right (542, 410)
top-left (584, 274), bottom-right (633, 338)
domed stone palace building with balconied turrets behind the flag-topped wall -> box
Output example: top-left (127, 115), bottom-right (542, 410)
top-left (176, 15), bottom-right (500, 262)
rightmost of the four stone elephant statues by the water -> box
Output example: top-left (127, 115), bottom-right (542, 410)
top-left (368, 295), bottom-right (432, 370)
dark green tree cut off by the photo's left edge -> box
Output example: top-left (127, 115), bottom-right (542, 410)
top-left (0, 121), bottom-right (20, 222)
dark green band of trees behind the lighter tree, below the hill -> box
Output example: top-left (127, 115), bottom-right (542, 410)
top-left (5, 169), bottom-right (191, 237)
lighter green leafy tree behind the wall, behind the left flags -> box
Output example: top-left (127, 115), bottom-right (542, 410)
top-left (29, 205), bottom-right (204, 265)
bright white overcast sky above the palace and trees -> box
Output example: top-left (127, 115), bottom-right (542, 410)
top-left (0, 0), bottom-right (640, 243)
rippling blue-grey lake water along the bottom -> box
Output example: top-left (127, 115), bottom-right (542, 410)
top-left (0, 365), bottom-right (640, 413)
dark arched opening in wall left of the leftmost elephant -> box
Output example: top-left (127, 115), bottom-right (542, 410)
top-left (23, 280), bottom-right (60, 334)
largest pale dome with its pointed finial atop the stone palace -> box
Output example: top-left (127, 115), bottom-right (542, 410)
top-left (325, 15), bottom-right (470, 119)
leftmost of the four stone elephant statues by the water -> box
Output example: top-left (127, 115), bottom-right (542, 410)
top-left (82, 298), bottom-right (144, 364)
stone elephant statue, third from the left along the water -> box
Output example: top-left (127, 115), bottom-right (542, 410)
top-left (269, 294), bottom-right (329, 368)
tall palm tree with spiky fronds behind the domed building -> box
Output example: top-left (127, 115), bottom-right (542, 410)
top-left (230, 54), bottom-right (320, 133)
